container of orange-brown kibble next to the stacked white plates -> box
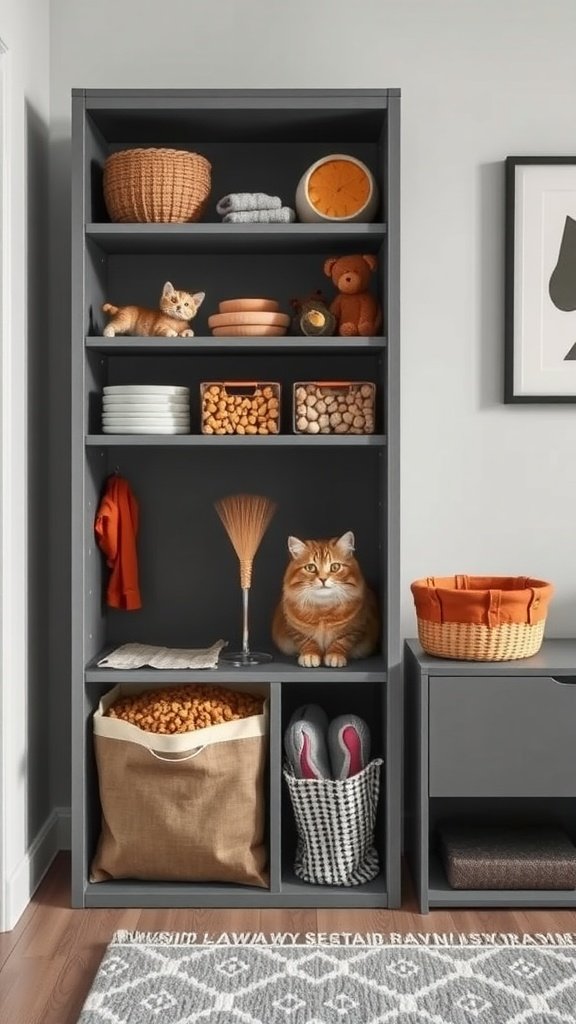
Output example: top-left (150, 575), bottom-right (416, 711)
top-left (200, 381), bottom-right (281, 436)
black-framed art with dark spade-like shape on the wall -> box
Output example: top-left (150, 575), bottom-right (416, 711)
top-left (504, 157), bottom-right (576, 402)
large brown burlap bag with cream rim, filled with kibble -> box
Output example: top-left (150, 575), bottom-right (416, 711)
top-left (90, 684), bottom-right (269, 887)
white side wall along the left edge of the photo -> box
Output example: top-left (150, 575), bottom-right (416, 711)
top-left (0, 0), bottom-right (50, 929)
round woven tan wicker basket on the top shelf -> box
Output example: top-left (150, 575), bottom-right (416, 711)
top-left (104, 148), bottom-right (212, 224)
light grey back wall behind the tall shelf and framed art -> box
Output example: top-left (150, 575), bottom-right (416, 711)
top-left (50, 0), bottom-right (576, 804)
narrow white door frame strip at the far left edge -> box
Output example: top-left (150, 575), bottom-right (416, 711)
top-left (0, 39), bottom-right (10, 932)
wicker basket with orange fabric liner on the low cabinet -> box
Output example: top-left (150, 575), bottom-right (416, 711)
top-left (410, 575), bottom-right (553, 662)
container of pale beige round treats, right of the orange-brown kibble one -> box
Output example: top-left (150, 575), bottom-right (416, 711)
top-left (293, 381), bottom-right (376, 434)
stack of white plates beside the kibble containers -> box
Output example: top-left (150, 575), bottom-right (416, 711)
top-left (102, 384), bottom-right (190, 434)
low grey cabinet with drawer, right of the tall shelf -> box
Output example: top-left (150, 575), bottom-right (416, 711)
top-left (405, 640), bottom-right (576, 912)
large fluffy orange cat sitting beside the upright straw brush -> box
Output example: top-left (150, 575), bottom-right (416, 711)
top-left (272, 531), bottom-right (379, 669)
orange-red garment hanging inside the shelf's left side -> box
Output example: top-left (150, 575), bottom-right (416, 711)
top-left (94, 475), bottom-right (141, 611)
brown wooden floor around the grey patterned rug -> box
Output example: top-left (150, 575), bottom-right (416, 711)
top-left (0, 853), bottom-right (576, 1024)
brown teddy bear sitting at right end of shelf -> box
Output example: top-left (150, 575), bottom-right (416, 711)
top-left (324, 255), bottom-right (382, 337)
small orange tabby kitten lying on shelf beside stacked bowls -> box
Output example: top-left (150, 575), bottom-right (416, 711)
top-left (102, 281), bottom-right (205, 338)
